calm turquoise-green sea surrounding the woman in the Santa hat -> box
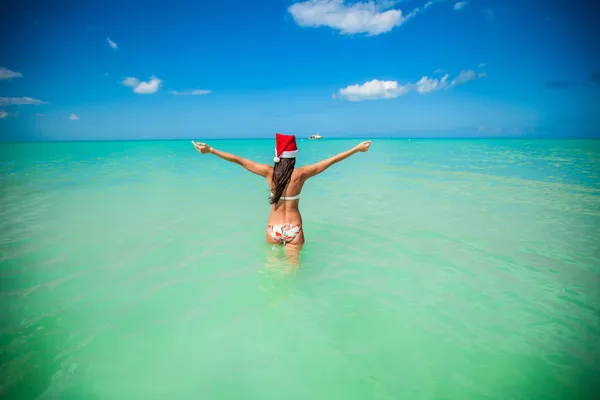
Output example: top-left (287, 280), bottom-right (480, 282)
top-left (0, 138), bottom-right (600, 400)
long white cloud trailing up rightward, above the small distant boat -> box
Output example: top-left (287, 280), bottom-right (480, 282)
top-left (333, 66), bottom-right (486, 102)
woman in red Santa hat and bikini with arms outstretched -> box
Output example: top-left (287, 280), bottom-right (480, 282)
top-left (192, 133), bottom-right (371, 256)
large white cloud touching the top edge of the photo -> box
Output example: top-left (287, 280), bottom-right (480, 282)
top-left (288, 0), bottom-right (433, 36)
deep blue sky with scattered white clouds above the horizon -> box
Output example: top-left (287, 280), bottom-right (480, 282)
top-left (0, 0), bottom-right (600, 141)
